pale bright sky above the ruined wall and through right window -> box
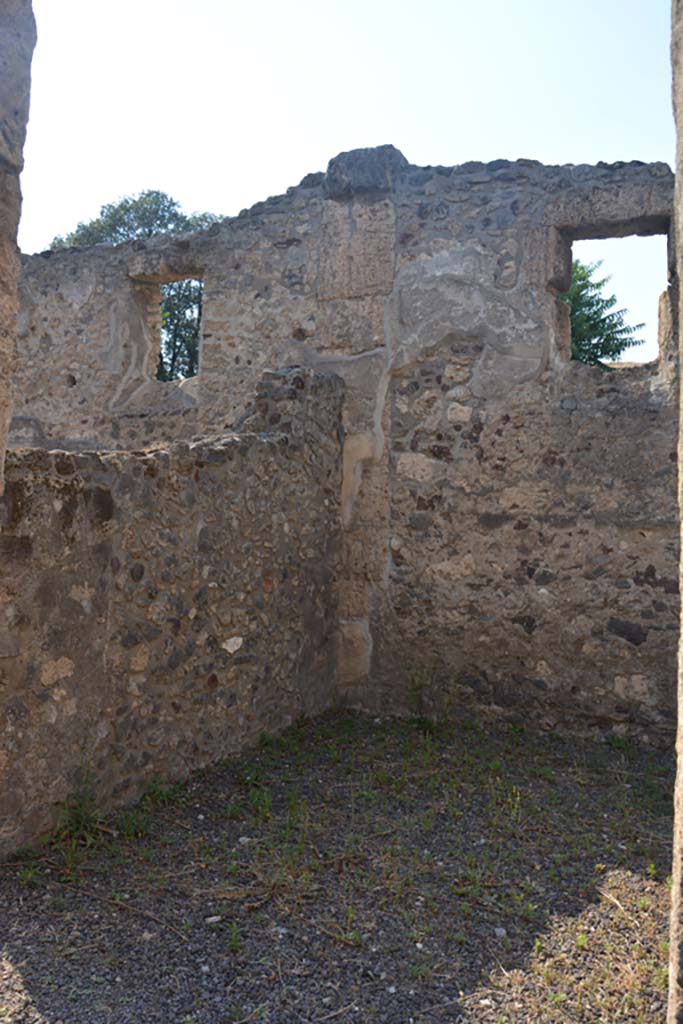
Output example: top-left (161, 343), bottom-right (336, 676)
top-left (19, 0), bottom-right (674, 357)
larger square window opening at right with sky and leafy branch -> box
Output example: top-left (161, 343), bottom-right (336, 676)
top-left (562, 234), bottom-right (670, 369)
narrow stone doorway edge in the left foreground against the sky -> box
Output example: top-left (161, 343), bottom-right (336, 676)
top-left (0, 0), bottom-right (36, 493)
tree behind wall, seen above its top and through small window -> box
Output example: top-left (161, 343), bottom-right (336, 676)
top-left (50, 188), bottom-right (221, 381)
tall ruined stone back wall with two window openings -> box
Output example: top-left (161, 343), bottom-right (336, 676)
top-left (13, 146), bottom-right (678, 741)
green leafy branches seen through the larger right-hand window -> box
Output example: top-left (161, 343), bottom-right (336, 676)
top-left (560, 259), bottom-right (645, 368)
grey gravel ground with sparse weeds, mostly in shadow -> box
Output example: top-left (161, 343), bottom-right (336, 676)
top-left (0, 714), bottom-right (674, 1024)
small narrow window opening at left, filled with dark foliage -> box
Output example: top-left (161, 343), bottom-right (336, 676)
top-left (157, 278), bottom-right (204, 381)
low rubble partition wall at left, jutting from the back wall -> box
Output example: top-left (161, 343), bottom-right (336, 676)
top-left (0, 371), bottom-right (342, 853)
